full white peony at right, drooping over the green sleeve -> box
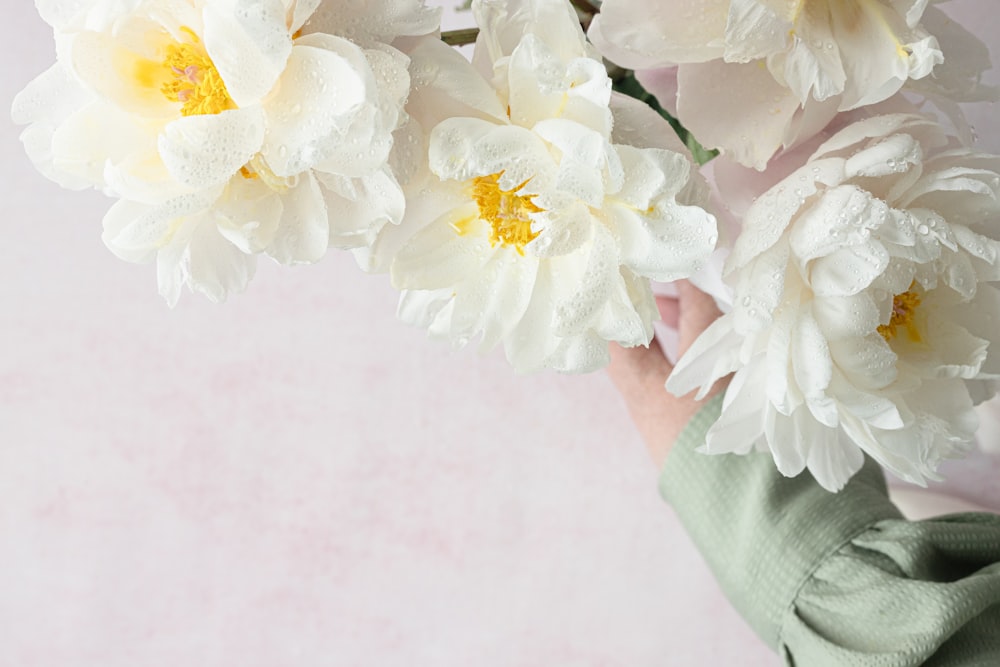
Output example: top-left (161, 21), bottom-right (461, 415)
top-left (667, 114), bottom-right (1000, 490)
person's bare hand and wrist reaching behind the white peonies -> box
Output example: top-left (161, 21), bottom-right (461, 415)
top-left (607, 280), bottom-right (729, 468)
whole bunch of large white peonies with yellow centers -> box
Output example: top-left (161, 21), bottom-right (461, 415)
top-left (14, 0), bottom-right (1000, 489)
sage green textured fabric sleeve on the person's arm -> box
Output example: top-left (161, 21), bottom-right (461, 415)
top-left (660, 397), bottom-right (1000, 667)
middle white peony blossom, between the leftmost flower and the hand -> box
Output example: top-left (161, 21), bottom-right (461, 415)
top-left (377, 0), bottom-right (716, 372)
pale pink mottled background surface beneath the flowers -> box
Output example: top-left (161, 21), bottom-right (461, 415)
top-left (0, 0), bottom-right (1000, 667)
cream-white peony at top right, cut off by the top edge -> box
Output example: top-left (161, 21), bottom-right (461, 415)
top-left (590, 0), bottom-right (985, 169)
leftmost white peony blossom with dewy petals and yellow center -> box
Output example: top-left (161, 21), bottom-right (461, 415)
top-left (13, 0), bottom-right (439, 301)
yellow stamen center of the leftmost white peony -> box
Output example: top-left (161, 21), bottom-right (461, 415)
top-left (160, 28), bottom-right (236, 116)
